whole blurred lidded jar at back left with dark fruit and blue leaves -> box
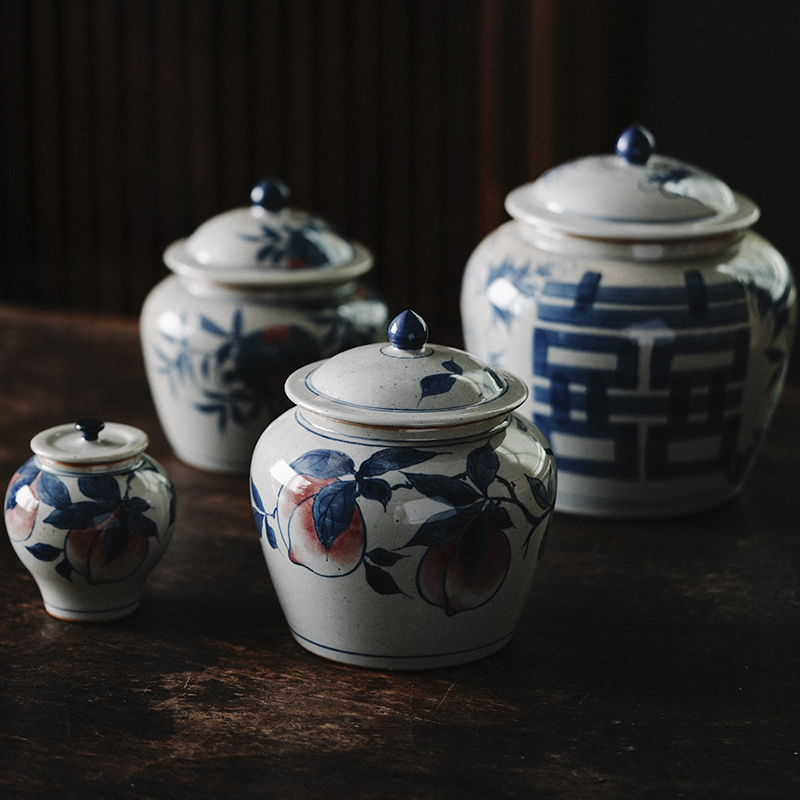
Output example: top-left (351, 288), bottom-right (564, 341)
top-left (141, 180), bottom-right (387, 473)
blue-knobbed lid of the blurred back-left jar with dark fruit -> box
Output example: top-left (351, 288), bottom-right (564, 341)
top-left (164, 178), bottom-right (372, 287)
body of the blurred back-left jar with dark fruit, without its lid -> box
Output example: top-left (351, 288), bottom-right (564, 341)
top-left (141, 275), bottom-right (387, 473)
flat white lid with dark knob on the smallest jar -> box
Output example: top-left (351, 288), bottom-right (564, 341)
top-left (31, 419), bottom-right (148, 467)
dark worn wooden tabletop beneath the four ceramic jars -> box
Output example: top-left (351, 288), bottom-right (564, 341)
top-left (0, 307), bottom-right (800, 800)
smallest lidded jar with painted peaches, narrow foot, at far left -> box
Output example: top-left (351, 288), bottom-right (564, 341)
top-left (5, 419), bottom-right (175, 622)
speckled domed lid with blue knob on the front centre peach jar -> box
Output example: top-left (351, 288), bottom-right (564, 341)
top-left (286, 311), bottom-right (528, 428)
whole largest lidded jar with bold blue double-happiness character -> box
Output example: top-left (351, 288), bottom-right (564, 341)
top-left (461, 126), bottom-right (795, 517)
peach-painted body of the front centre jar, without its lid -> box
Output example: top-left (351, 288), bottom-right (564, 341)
top-left (251, 409), bottom-right (556, 670)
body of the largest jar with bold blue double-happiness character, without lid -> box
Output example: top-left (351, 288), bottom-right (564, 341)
top-left (461, 220), bottom-right (795, 517)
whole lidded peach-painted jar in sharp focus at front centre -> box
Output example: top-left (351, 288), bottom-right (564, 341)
top-left (251, 311), bottom-right (556, 669)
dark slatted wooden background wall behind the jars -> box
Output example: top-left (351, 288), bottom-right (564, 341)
top-left (0, 0), bottom-right (800, 376)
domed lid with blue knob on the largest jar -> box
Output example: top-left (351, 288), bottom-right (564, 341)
top-left (506, 125), bottom-right (759, 240)
